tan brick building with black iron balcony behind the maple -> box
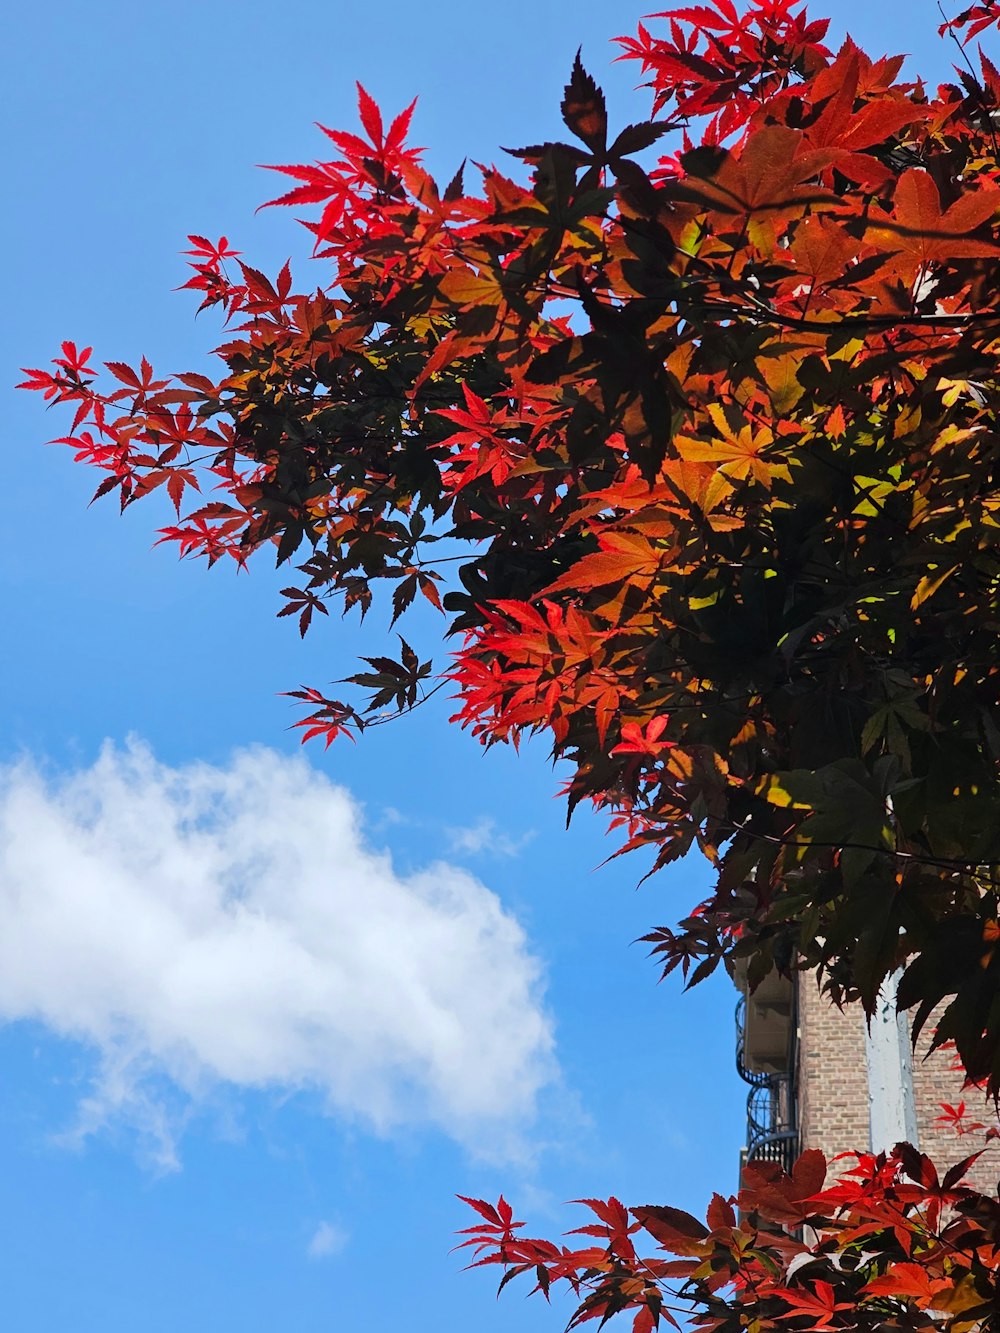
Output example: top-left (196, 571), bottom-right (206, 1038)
top-left (736, 973), bottom-right (1000, 1192)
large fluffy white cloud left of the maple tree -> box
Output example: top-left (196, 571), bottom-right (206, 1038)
top-left (0, 744), bottom-right (555, 1166)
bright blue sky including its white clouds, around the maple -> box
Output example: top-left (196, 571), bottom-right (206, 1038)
top-left (0, 0), bottom-right (965, 1333)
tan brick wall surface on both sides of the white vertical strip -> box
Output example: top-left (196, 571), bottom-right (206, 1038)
top-left (799, 973), bottom-right (1000, 1193)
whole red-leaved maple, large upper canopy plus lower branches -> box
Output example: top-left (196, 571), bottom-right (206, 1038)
top-left (17, 0), bottom-right (1000, 1329)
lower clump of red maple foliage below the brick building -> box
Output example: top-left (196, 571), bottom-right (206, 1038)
top-left (463, 1144), bottom-right (1000, 1333)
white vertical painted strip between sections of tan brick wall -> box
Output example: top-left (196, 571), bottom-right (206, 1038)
top-left (864, 969), bottom-right (920, 1153)
